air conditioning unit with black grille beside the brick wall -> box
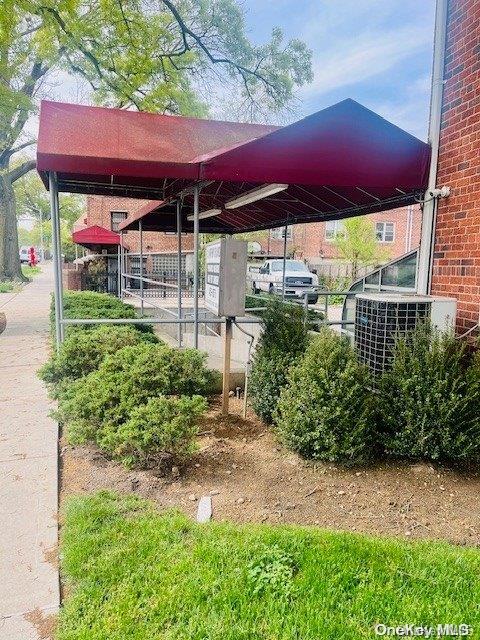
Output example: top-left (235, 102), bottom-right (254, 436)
top-left (355, 293), bottom-right (457, 374)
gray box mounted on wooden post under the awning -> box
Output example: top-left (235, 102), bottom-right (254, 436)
top-left (205, 238), bottom-right (247, 317)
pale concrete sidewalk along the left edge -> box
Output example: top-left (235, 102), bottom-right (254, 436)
top-left (0, 265), bottom-right (59, 640)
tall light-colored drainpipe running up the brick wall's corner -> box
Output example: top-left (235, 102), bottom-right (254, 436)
top-left (417, 0), bottom-right (448, 294)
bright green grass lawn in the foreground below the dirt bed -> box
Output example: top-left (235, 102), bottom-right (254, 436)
top-left (58, 493), bottom-right (480, 640)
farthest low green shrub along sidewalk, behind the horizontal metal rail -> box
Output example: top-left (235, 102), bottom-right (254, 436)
top-left (55, 291), bottom-right (153, 335)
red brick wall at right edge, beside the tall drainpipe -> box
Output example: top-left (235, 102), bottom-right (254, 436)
top-left (431, 0), bottom-right (480, 330)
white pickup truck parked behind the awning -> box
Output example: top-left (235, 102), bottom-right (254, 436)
top-left (250, 259), bottom-right (318, 304)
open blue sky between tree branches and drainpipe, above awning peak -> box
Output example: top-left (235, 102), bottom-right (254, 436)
top-left (243, 0), bottom-right (435, 139)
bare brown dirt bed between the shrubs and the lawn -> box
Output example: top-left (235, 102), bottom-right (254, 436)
top-left (61, 400), bottom-right (480, 545)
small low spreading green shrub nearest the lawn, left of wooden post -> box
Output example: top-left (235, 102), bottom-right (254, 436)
top-left (98, 396), bottom-right (207, 466)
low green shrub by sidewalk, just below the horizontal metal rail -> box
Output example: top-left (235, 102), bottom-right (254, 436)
top-left (38, 325), bottom-right (157, 395)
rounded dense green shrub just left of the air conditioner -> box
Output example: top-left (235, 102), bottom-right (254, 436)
top-left (275, 329), bottom-right (375, 464)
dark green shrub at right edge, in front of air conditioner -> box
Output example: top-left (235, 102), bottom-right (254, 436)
top-left (379, 325), bottom-right (480, 461)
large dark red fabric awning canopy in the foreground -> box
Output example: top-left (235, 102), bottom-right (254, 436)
top-left (37, 100), bottom-right (430, 233)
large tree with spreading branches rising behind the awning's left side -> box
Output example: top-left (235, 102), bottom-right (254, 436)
top-left (0, 0), bottom-right (312, 280)
